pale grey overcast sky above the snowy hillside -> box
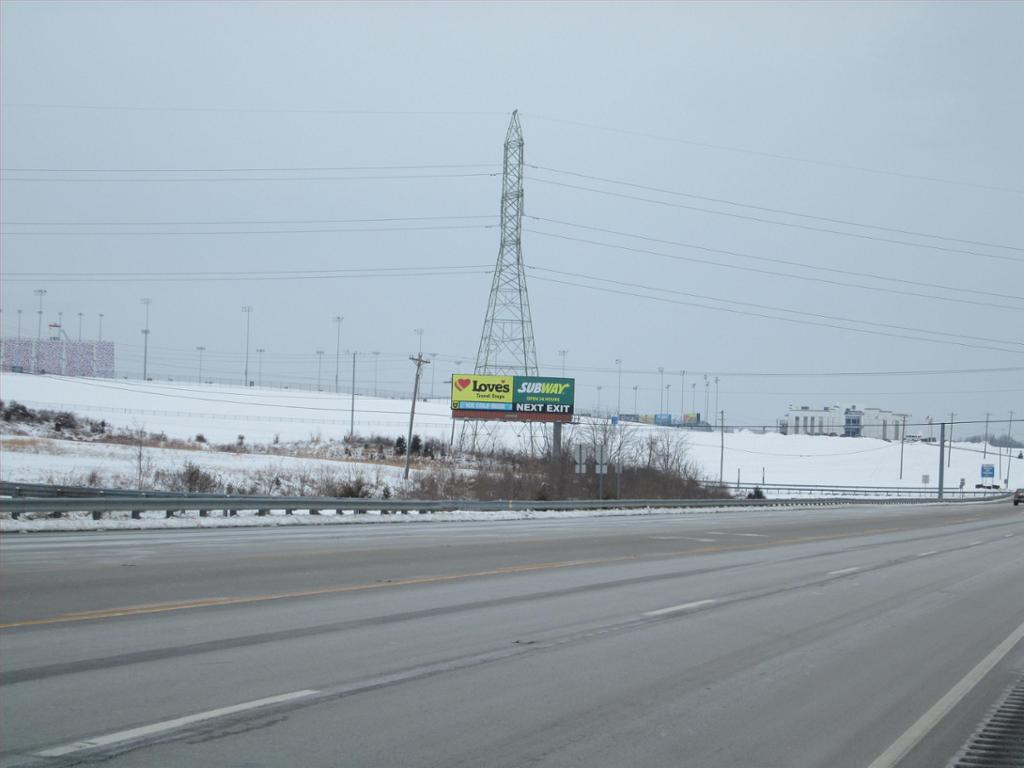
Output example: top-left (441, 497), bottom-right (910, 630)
top-left (0, 2), bottom-right (1024, 432)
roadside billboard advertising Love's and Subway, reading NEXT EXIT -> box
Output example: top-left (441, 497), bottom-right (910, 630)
top-left (452, 374), bottom-right (575, 422)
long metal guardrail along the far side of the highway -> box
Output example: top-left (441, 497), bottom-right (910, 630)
top-left (0, 483), bottom-right (1007, 520)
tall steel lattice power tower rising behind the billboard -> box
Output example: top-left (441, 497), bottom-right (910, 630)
top-left (476, 110), bottom-right (538, 376)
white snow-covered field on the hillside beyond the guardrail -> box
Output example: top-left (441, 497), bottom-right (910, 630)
top-left (0, 373), bottom-right (1024, 489)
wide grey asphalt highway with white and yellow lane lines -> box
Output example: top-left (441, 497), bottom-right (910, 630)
top-left (0, 502), bottom-right (1024, 768)
